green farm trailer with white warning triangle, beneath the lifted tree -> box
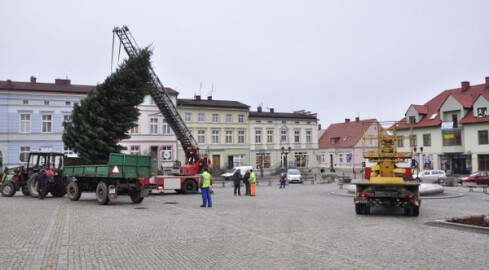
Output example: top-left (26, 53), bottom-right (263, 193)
top-left (63, 153), bottom-right (151, 205)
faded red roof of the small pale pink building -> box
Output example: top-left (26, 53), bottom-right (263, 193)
top-left (318, 119), bottom-right (377, 148)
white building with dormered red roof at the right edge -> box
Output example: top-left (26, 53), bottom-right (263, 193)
top-left (398, 77), bottom-right (489, 174)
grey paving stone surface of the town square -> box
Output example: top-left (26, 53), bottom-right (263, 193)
top-left (0, 183), bottom-right (489, 270)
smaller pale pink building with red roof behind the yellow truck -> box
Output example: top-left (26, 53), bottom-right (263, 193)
top-left (318, 117), bottom-right (377, 171)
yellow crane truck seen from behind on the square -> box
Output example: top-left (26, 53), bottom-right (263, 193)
top-left (353, 122), bottom-right (421, 216)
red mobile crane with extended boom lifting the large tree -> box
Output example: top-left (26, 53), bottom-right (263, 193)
top-left (113, 26), bottom-right (204, 193)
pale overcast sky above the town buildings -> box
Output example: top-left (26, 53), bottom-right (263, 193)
top-left (0, 0), bottom-right (489, 128)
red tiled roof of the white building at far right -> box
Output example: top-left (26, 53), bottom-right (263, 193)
top-left (398, 80), bottom-right (489, 129)
